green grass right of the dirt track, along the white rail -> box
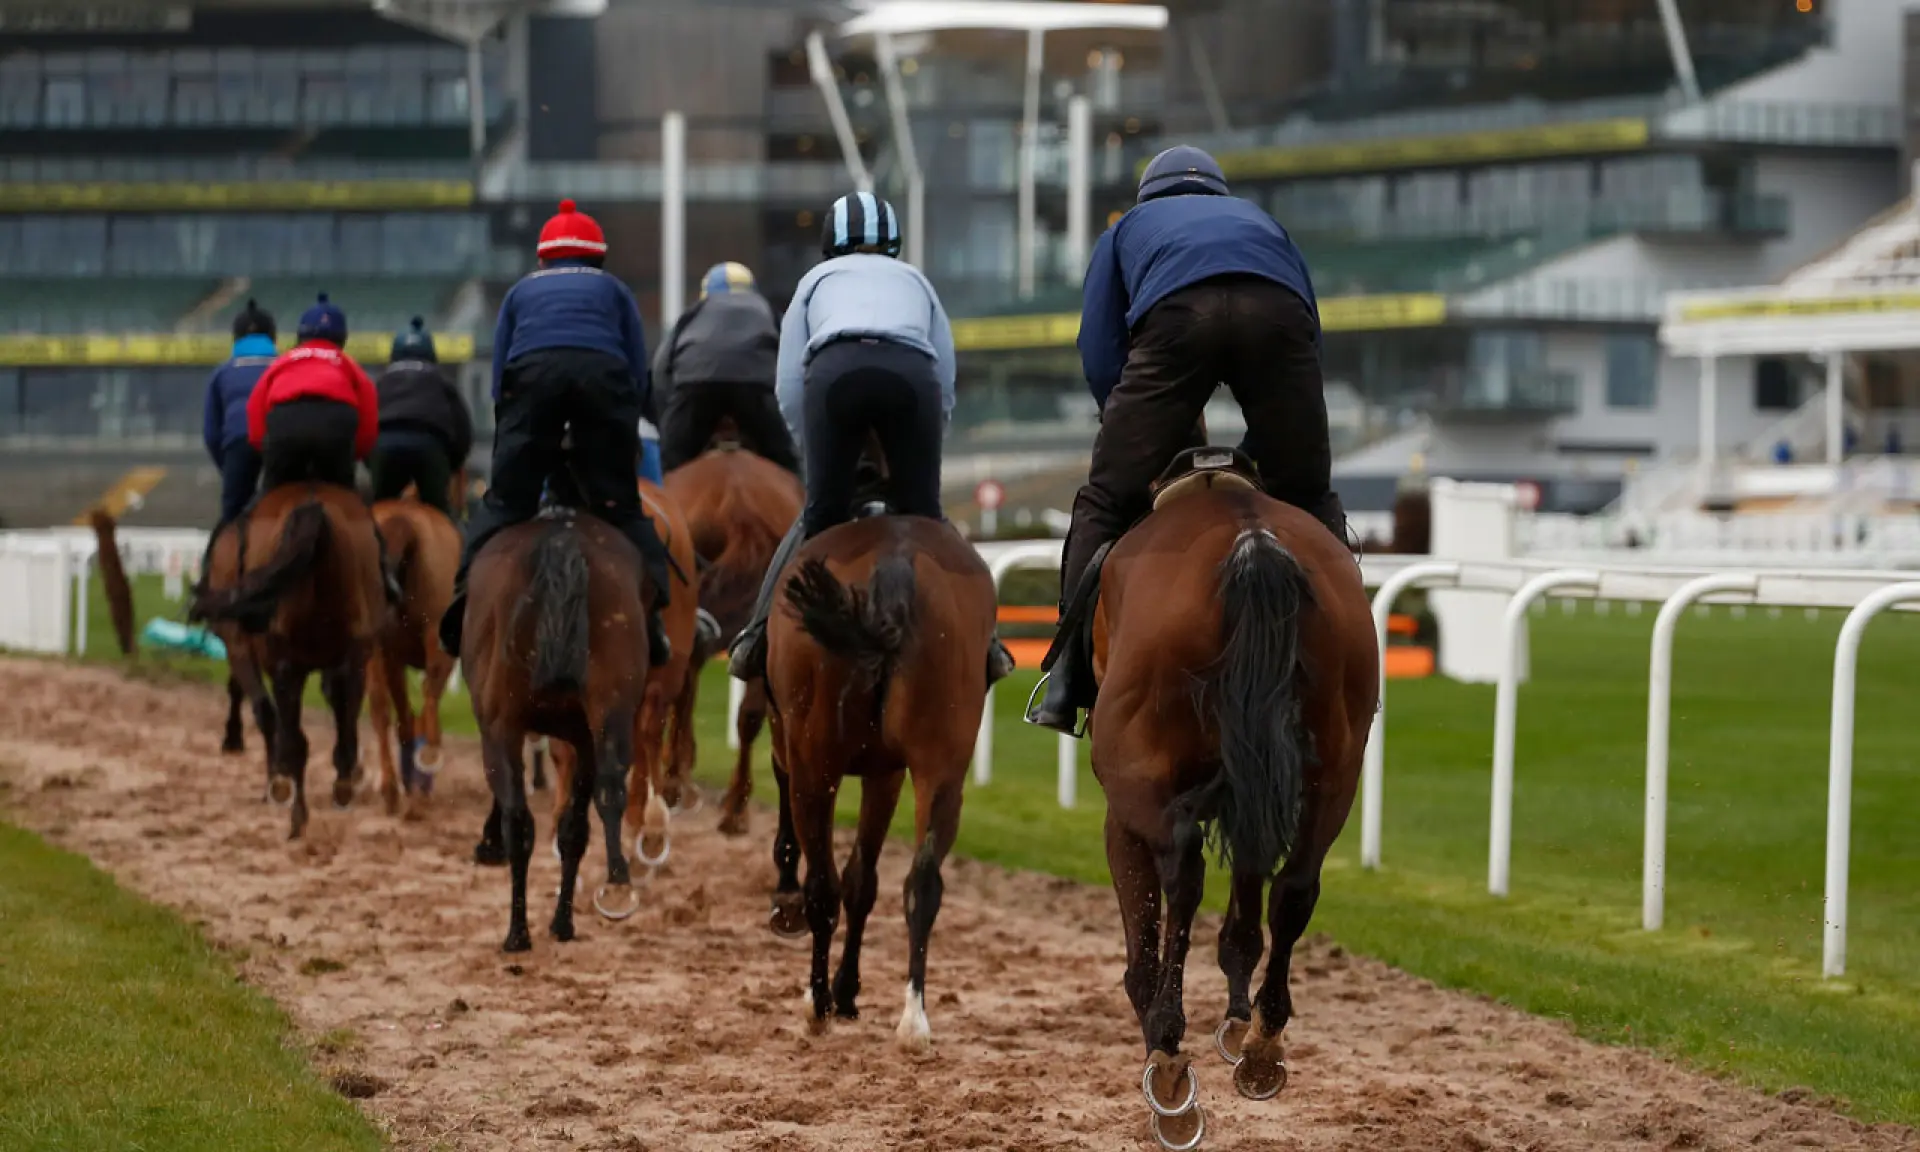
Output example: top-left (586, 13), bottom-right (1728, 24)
top-left (74, 579), bottom-right (1920, 1123)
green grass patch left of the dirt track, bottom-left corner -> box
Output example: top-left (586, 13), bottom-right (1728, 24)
top-left (0, 824), bottom-right (382, 1152)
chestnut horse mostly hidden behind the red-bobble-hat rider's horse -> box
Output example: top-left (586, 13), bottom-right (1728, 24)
top-left (536, 480), bottom-right (710, 868)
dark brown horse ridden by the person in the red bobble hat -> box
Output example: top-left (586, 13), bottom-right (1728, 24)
top-left (461, 505), bottom-right (649, 952)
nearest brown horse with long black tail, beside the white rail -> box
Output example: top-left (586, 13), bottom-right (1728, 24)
top-left (1091, 449), bottom-right (1380, 1148)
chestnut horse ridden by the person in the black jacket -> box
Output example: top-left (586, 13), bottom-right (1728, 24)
top-left (367, 488), bottom-right (461, 816)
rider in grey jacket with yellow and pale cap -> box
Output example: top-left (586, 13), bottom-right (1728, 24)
top-left (653, 263), bottom-right (801, 476)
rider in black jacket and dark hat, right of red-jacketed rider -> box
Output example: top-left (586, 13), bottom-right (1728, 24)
top-left (367, 317), bottom-right (474, 518)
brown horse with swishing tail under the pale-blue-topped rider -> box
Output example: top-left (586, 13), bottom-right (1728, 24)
top-left (766, 516), bottom-right (995, 1048)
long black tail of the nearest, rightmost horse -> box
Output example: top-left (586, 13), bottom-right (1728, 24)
top-left (1183, 528), bottom-right (1313, 876)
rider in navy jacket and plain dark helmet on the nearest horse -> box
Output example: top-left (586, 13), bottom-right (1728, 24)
top-left (1027, 146), bottom-right (1346, 733)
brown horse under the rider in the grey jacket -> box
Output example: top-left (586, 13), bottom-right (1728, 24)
top-left (666, 442), bottom-right (804, 835)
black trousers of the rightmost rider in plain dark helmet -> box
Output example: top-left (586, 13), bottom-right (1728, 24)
top-left (1060, 276), bottom-right (1338, 603)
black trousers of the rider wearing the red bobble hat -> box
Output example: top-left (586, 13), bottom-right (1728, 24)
top-left (457, 348), bottom-right (668, 607)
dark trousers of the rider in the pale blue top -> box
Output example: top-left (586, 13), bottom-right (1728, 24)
top-left (801, 340), bottom-right (945, 538)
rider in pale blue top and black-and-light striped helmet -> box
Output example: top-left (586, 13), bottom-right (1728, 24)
top-left (730, 192), bottom-right (1014, 684)
